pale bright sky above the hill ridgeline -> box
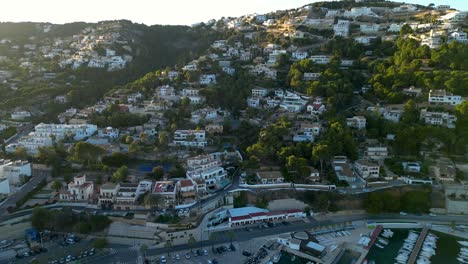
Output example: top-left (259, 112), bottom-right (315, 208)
top-left (0, 0), bottom-right (468, 25)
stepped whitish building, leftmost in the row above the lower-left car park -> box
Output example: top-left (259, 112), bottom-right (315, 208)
top-left (60, 175), bottom-right (94, 201)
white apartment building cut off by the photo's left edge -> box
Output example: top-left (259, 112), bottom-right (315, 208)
top-left (0, 159), bottom-right (32, 185)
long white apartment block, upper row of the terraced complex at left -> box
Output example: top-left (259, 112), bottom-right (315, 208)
top-left (34, 123), bottom-right (97, 140)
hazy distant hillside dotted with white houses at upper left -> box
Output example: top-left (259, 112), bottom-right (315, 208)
top-left (0, 20), bottom-right (216, 115)
